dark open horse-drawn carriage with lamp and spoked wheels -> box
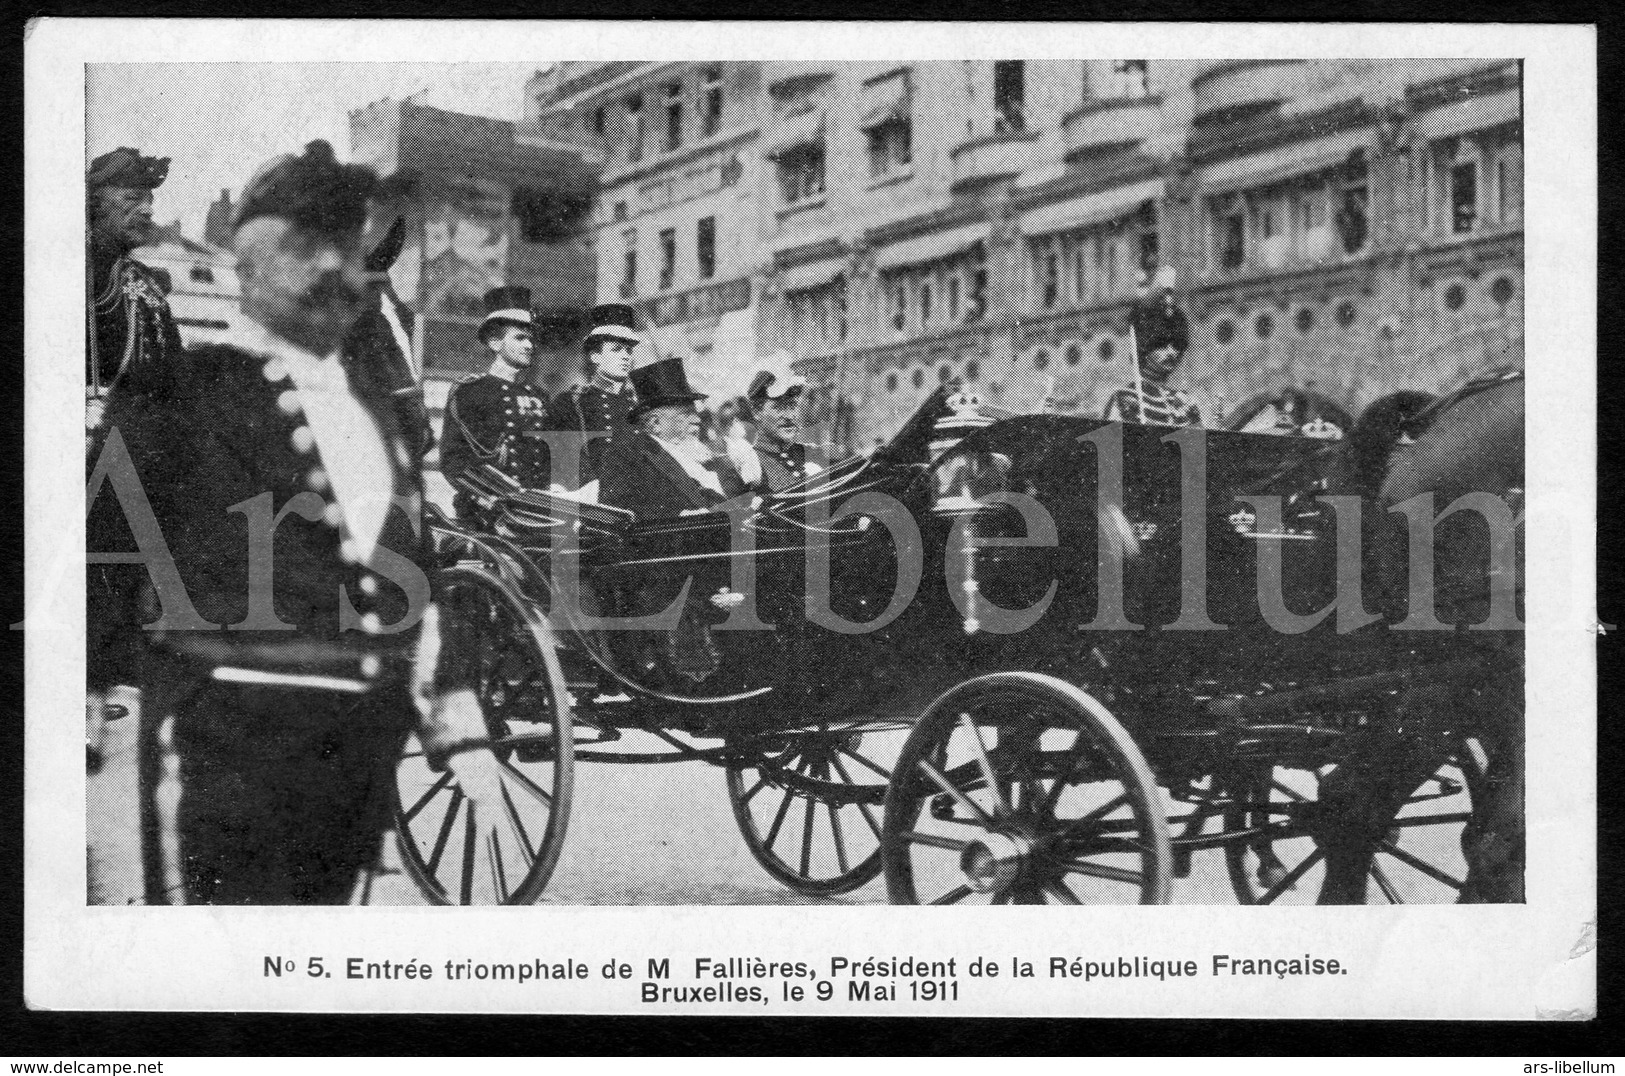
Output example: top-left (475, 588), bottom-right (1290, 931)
top-left (398, 378), bottom-right (1521, 904)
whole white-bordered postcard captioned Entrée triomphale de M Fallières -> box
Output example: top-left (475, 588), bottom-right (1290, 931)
top-left (23, 20), bottom-right (1601, 1019)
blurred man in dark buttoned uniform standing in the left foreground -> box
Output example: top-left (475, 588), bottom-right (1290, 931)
top-left (89, 141), bottom-right (496, 904)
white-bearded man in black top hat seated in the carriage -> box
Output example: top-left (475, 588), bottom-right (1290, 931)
top-left (600, 358), bottom-right (749, 518)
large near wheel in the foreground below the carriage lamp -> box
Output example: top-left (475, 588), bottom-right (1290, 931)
top-left (882, 673), bottom-right (1173, 904)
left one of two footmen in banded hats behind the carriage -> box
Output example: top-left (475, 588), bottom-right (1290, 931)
top-left (440, 288), bottom-right (549, 515)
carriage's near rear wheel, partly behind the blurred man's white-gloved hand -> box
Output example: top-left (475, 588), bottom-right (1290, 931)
top-left (395, 566), bottom-right (574, 904)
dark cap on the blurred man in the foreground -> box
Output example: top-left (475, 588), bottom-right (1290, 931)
top-left (231, 138), bottom-right (379, 237)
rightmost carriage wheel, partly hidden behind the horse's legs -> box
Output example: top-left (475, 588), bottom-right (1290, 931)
top-left (1224, 741), bottom-right (1485, 904)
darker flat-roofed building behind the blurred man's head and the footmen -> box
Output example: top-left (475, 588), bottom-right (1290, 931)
top-left (349, 99), bottom-right (598, 414)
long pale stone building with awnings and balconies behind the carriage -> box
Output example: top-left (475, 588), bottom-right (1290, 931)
top-left (528, 60), bottom-right (1523, 449)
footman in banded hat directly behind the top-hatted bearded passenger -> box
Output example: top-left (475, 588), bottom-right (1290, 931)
top-left (548, 302), bottom-right (644, 486)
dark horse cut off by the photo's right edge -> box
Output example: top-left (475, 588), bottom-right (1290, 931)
top-left (1321, 371), bottom-right (1524, 904)
